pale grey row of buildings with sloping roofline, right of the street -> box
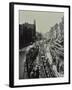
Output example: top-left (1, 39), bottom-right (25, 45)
top-left (47, 17), bottom-right (64, 40)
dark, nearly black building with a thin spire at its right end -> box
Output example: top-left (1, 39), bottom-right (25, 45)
top-left (19, 20), bottom-right (36, 49)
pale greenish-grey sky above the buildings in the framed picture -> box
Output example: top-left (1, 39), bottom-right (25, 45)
top-left (19, 10), bottom-right (64, 33)
